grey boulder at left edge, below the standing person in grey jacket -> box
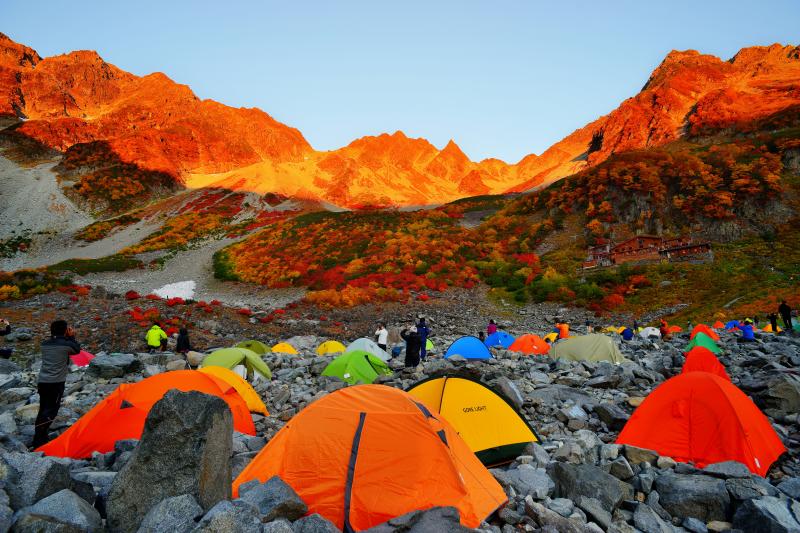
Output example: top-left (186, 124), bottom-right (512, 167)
top-left (0, 452), bottom-right (71, 510)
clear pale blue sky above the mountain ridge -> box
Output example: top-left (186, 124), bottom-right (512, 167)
top-left (0, 0), bottom-right (800, 162)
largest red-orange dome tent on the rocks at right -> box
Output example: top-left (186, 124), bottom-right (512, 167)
top-left (617, 372), bottom-right (786, 476)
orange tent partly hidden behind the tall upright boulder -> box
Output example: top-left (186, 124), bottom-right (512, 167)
top-left (36, 370), bottom-right (256, 459)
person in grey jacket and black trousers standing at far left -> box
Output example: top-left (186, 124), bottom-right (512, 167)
top-left (33, 320), bottom-right (81, 449)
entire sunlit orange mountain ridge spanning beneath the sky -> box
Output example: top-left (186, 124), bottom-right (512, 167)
top-left (0, 34), bottom-right (800, 207)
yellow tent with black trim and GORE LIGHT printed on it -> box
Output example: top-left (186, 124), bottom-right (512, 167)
top-left (408, 376), bottom-right (539, 465)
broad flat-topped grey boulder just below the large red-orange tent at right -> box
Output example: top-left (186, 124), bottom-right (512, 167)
top-left (656, 473), bottom-right (731, 522)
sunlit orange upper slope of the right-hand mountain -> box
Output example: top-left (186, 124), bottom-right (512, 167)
top-left (511, 44), bottom-right (800, 191)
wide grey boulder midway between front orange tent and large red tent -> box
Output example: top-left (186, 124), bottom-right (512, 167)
top-left (548, 463), bottom-right (633, 513)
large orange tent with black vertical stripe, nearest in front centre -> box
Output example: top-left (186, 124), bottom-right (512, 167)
top-left (233, 385), bottom-right (506, 531)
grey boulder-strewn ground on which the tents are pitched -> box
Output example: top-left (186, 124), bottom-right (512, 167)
top-left (0, 291), bottom-right (800, 532)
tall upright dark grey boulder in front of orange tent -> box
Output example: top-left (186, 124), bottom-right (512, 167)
top-left (106, 390), bottom-right (233, 532)
